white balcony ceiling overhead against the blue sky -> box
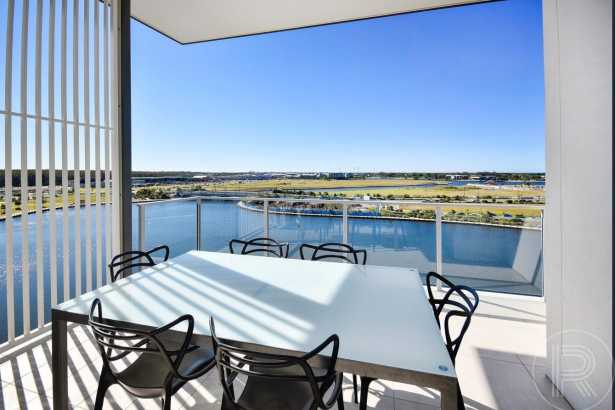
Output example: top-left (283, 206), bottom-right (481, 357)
top-left (131, 0), bottom-right (488, 44)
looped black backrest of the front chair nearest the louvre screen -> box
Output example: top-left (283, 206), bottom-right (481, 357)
top-left (88, 299), bottom-right (194, 379)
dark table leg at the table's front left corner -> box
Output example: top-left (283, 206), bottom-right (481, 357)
top-left (51, 313), bottom-right (68, 410)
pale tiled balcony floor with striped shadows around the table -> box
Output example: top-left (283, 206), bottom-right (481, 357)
top-left (0, 296), bottom-right (571, 410)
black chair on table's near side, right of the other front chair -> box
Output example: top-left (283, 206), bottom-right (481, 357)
top-left (209, 317), bottom-right (344, 410)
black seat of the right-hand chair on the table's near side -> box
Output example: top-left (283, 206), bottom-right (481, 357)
top-left (222, 366), bottom-right (327, 410)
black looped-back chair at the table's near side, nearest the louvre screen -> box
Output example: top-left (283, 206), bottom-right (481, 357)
top-left (88, 299), bottom-right (215, 410)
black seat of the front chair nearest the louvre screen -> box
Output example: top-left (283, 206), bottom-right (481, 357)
top-left (116, 347), bottom-right (215, 398)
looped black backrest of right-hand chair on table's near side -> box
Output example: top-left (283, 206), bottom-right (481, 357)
top-left (209, 317), bottom-right (342, 410)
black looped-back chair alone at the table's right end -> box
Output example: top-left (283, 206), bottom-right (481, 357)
top-left (360, 278), bottom-right (480, 409)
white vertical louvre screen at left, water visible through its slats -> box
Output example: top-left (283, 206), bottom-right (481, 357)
top-left (0, 0), bottom-right (118, 350)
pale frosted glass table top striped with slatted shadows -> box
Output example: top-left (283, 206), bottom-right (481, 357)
top-left (54, 251), bottom-right (456, 377)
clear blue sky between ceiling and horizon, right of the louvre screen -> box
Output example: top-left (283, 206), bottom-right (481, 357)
top-left (132, 0), bottom-right (545, 172)
